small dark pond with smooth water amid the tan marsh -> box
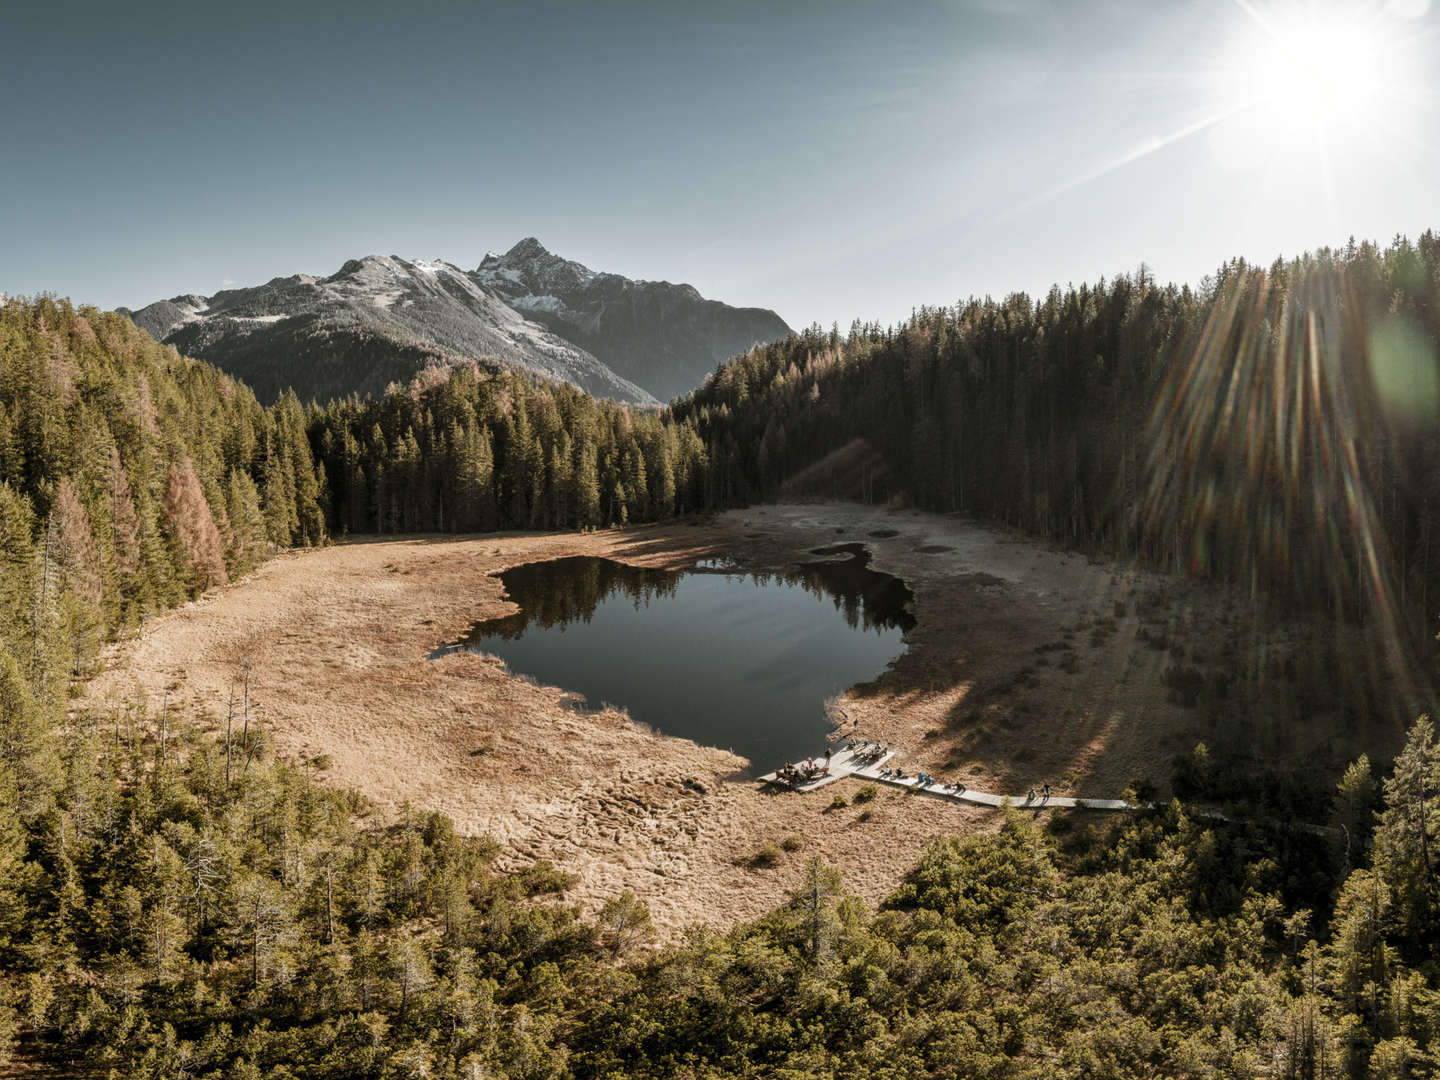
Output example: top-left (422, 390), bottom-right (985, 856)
top-left (431, 544), bottom-right (914, 772)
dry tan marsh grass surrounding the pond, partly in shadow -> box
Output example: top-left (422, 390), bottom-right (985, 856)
top-left (76, 505), bottom-right (1393, 937)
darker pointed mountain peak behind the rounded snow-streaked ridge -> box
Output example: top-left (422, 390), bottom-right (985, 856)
top-left (474, 236), bottom-right (791, 400)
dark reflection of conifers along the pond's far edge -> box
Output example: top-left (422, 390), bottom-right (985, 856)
top-left (449, 552), bottom-right (914, 645)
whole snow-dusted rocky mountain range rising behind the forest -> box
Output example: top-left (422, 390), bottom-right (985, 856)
top-left (121, 238), bottom-right (791, 405)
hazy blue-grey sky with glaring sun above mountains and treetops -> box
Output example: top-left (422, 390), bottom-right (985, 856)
top-left (0, 0), bottom-right (1440, 325)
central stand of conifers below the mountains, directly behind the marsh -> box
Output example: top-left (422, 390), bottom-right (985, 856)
top-left (310, 364), bottom-right (713, 534)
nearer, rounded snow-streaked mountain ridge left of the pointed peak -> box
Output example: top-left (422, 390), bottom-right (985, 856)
top-left (125, 255), bottom-right (655, 405)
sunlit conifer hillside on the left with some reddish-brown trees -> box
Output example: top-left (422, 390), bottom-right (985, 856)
top-left (0, 298), bottom-right (327, 679)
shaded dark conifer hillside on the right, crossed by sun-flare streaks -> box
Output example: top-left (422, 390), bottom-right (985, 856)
top-left (674, 232), bottom-right (1440, 648)
